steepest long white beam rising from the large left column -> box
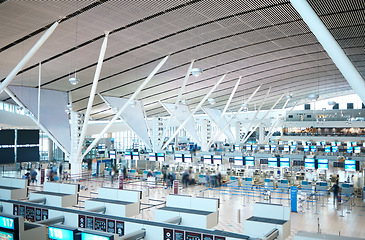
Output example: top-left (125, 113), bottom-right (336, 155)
top-left (77, 32), bottom-right (109, 156)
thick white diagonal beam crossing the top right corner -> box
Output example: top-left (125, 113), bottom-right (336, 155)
top-left (290, 0), bottom-right (365, 103)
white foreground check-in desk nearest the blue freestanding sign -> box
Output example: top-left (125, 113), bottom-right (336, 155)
top-left (244, 203), bottom-right (291, 240)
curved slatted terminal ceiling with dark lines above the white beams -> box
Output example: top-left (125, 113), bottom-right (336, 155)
top-left (0, 0), bottom-right (365, 120)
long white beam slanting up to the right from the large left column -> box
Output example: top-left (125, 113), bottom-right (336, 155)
top-left (82, 56), bottom-right (169, 158)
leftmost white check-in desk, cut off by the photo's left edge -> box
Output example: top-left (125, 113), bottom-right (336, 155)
top-left (0, 177), bottom-right (27, 200)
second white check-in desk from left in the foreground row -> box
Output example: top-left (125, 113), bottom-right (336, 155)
top-left (29, 182), bottom-right (79, 207)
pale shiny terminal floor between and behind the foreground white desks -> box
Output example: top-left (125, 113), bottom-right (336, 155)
top-left (3, 173), bottom-right (365, 239)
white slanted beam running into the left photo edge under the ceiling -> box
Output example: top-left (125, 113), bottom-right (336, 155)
top-left (0, 22), bottom-right (58, 93)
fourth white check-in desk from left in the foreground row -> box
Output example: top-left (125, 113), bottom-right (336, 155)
top-left (155, 195), bottom-right (219, 228)
